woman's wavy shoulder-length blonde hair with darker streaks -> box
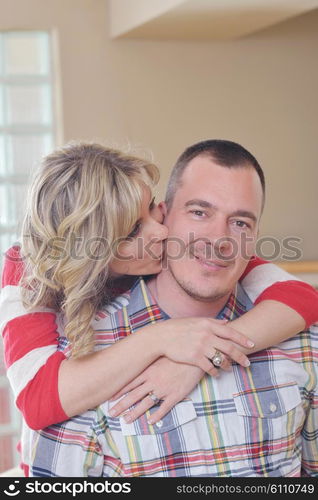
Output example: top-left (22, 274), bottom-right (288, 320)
top-left (21, 142), bottom-right (159, 357)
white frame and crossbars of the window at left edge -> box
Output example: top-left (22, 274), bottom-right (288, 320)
top-left (0, 30), bottom-right (57, 473)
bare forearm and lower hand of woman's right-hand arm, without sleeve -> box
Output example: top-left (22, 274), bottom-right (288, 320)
top-left (106, 296), bottom-right (314, 424)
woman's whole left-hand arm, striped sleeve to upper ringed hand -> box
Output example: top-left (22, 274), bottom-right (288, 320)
top-left (0, 247), bottom-right (248, 429)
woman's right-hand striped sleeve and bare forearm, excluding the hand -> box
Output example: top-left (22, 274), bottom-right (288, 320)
top-left (236, 257), bottom-right (318, 353)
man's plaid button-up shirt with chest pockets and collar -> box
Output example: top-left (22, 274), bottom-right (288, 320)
top-left (31, 278), bottom-right (318, 477)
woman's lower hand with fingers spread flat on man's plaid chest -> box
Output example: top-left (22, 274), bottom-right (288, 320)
top-left (110, 358), bottom-right (204, 424)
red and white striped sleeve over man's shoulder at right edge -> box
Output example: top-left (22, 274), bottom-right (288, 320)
top-left (241, 257), bottom-right (318, 327)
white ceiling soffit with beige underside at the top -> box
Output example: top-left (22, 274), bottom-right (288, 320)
top-left (109, 0), bottom-right (318, 40)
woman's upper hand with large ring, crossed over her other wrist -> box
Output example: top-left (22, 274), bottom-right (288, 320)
top-left (152, 318), bottom-right (254, 375)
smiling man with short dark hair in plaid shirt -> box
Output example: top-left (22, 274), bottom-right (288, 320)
top-left (32, 141), bottom-right (318, 477)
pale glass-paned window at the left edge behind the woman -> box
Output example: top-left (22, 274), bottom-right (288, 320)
top-left (0, 31), bottom-right (55, 472)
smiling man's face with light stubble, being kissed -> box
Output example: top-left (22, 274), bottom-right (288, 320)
top-left (165, 156), bottom-right (263, 301)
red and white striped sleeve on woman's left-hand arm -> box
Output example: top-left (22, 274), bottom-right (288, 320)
top-left (0, 247), bottom-right (68, 429)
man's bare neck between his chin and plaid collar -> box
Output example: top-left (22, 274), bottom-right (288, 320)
top-left (147, 271), bottom-right (230, 318)
